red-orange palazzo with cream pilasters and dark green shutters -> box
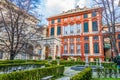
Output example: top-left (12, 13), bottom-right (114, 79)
top-left (47, 7), bottom-right (104, 61)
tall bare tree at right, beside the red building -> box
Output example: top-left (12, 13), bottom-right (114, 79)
top-left (93, 0), bottom-right (120, 56)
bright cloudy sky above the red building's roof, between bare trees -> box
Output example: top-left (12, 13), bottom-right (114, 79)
top-left (38, 0), bottom-right (90, 24)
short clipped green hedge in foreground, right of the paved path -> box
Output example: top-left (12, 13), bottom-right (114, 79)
top-left (70, 68), bottom-right (92, 80)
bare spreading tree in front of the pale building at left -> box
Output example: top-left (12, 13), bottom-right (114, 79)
top-left (0, 0), bottom-right (41, 60)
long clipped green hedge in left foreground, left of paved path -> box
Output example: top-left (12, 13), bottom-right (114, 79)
top-left (0, 66), bottom-right (64, 80)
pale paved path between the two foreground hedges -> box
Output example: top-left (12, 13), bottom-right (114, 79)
top-left (56, 67), bottom-right (80, 80)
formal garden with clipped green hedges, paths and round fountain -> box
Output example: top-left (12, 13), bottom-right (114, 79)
top-left (0, 59), bottom-right (120, 80)
